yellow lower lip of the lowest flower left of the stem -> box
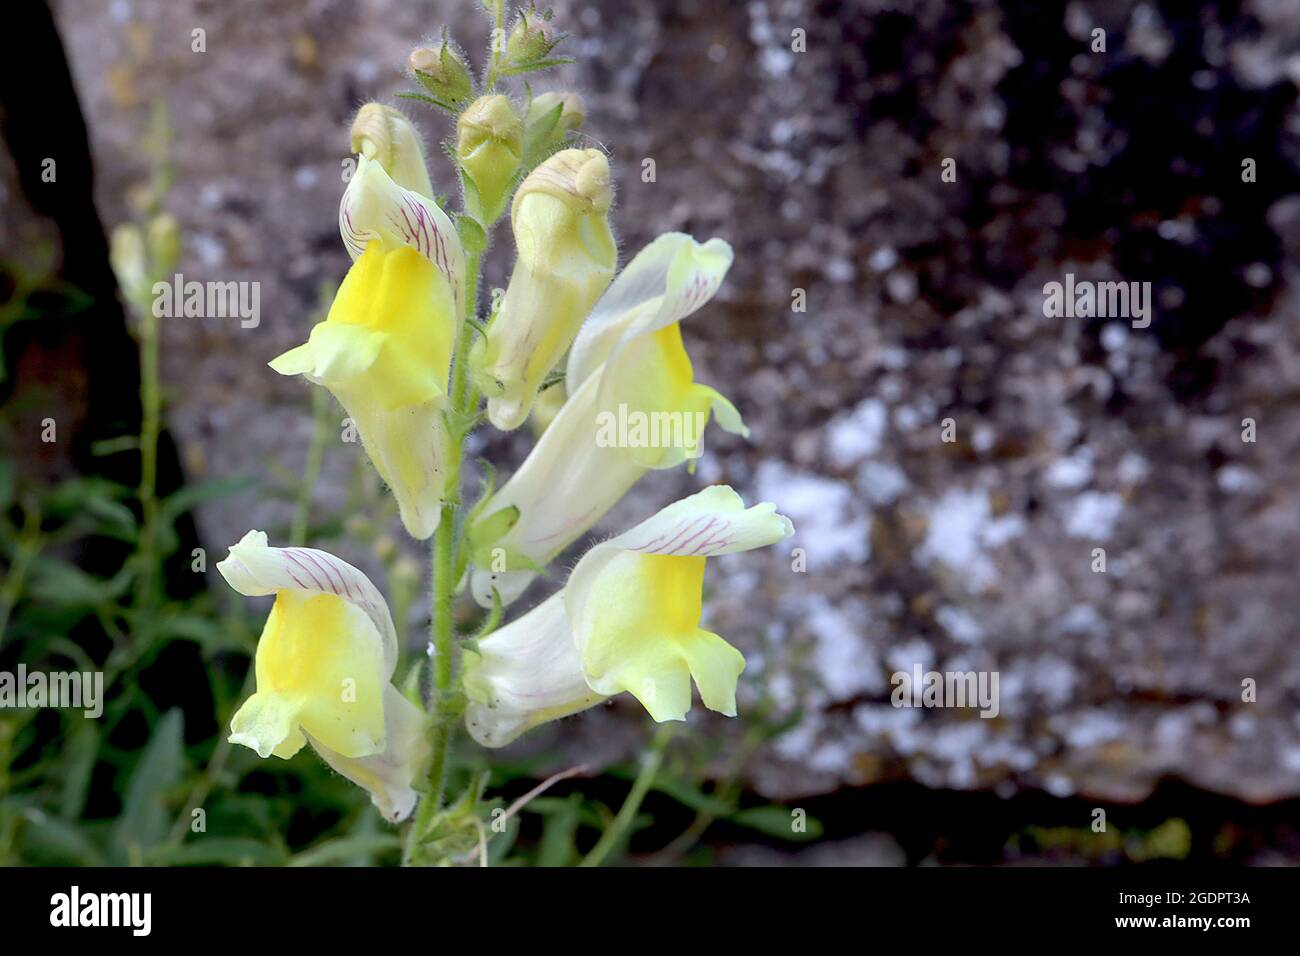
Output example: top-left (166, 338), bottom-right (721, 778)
top-left (231, 591), bottom-right (386, 758)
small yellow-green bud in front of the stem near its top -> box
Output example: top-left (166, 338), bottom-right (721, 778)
top-left (456, 95), bottom-right (524, 226)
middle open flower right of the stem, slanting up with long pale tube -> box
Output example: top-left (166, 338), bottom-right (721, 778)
top-left (469, 233), bottom-right (748, 607)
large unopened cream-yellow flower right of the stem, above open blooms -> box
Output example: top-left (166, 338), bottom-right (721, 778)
top-left (469, 150), bottom-right (618, 431)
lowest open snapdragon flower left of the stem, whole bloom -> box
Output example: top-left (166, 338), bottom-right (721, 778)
top-left (217, 531), bottom-right (428, 822)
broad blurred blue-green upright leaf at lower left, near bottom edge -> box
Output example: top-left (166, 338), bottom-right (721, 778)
top-left (109, 709), bottom-right (185, 865)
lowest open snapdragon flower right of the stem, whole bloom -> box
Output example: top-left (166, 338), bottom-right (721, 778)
top-left (464, 485), bottom-right (794, 747)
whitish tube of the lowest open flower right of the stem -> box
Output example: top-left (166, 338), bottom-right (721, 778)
top-left (464, 593), bottom-right (605, 747)
